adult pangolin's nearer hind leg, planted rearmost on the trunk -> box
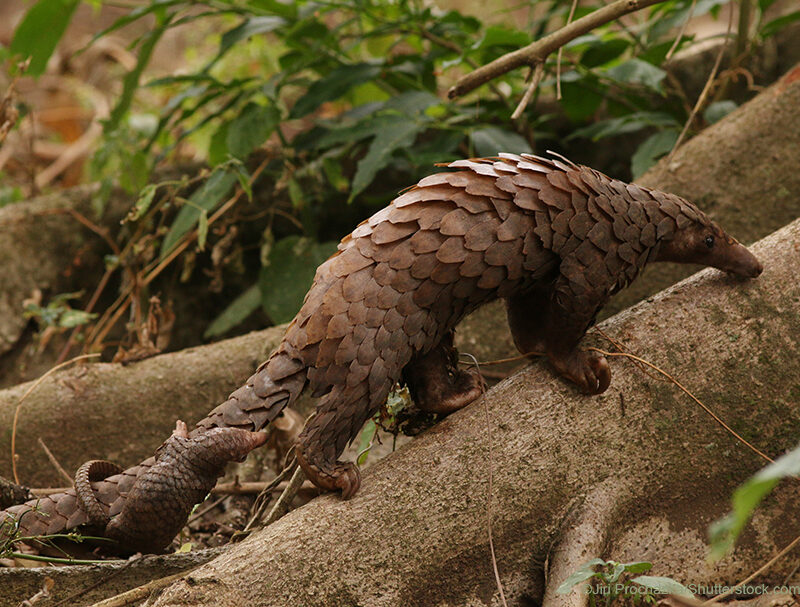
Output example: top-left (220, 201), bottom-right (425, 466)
top-left (295, 382), bottom-right (376, 499)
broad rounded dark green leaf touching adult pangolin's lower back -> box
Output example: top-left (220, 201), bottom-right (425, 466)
top-left (259, 236), bottom-right (336, 323)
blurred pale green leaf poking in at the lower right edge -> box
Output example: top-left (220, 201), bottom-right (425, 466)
top-left (710, 447), bottom-right (800, 559)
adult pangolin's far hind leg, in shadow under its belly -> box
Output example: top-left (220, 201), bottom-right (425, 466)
top-left (403, 331), bottom-right (485, 414)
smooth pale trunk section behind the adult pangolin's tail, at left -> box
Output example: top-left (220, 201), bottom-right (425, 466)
top-left (0, 327), bottom-right (283, 487)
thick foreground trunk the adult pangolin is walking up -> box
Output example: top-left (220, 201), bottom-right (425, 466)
top-left (142, 220), bottom-right (800, 607)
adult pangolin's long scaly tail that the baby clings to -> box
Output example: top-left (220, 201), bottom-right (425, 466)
top-left (0, 347), bottom-right (307, 541)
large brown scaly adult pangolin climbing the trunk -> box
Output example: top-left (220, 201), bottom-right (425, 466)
top-left (0, 154), bottom-right (762, 548)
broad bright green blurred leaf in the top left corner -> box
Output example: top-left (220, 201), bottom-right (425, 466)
top-left (11, 0), bottom-right (79, 76)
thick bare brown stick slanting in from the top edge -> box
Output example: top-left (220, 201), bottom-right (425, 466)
top-left (447, 0), bottom-right (665, 99)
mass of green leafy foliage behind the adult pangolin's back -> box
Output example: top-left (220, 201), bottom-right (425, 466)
top-left (7, 0), bottom-right (800, 335)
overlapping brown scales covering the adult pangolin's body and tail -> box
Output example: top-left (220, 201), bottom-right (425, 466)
top-left (3, 154), bottom-right (708, 534)
